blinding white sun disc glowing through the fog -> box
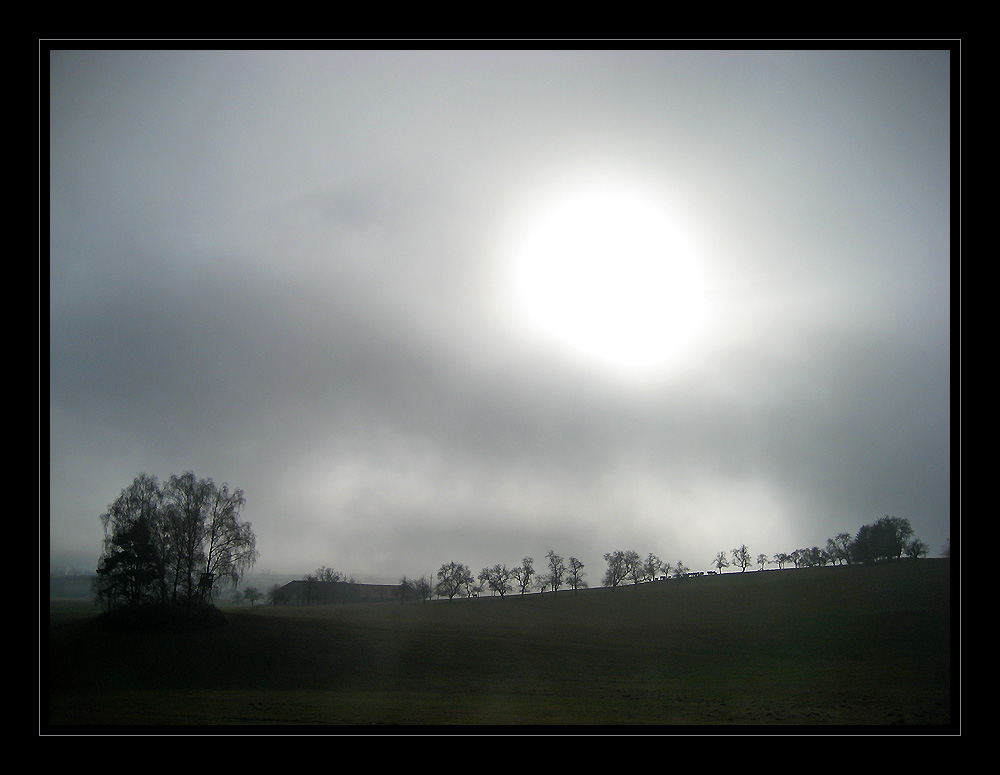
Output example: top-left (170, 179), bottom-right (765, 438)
top-left (515, 185), bottom-right (706, 370)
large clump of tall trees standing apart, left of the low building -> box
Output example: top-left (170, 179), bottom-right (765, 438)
top-left (94, 471), bottom-right (258, 611)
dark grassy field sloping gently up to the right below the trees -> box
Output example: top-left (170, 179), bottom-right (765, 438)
top-left (40, 559), bottom-right (958, 734)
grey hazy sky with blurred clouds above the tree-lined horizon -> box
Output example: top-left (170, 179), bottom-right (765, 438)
top-left (42, 50), bottom-right (952, 585)
